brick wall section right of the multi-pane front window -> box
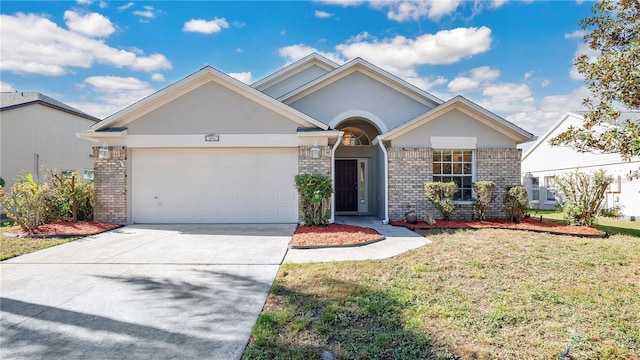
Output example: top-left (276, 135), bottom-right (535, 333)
top-left (476, 149), bottom-right (522, 218)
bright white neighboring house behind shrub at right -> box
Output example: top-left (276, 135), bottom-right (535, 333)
top-left (522, 113), bottom-right (640, 218)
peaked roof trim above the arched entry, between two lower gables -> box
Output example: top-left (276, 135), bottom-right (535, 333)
top-left (278, 58), bottom-right (442, 107)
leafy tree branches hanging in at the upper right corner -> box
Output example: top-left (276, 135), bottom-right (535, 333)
top-left (551, 0), bottom-right (640, 177)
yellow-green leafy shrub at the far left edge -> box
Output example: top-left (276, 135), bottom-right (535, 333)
top-left (0, 174), bottom-right (50, 230)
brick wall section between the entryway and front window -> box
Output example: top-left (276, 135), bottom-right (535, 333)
top-left (387, 147), bottom-right (437, 220)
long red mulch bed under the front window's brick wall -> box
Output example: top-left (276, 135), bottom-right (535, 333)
top-left (391, 219), bottom-right (607, 237)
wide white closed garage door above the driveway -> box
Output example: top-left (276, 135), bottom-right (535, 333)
top-left (131, 148), bottom-right (298, 223)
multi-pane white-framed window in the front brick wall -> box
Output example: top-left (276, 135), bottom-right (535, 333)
top-left (433, 150), bottom-right (474, 201)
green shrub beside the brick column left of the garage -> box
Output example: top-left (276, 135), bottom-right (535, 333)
top-left (47, 171), bottom-right (94, 221)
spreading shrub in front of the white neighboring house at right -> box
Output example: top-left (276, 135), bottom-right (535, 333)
top-left (557, 170), bottom-right (613, 226)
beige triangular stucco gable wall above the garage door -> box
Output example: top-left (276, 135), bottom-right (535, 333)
top-left (128, 82), bottom-right (300, 135)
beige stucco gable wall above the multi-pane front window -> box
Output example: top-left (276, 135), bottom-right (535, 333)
top-left (392, 110), bottom-right (516, 148)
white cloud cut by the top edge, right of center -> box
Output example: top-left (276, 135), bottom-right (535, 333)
top-left (378, 0), bottom-right (461, 22)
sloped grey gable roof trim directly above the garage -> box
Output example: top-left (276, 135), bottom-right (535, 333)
top-left (91, 66), bottom-right (328, 131)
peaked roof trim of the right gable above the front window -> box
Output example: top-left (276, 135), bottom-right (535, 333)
top-left (382, 95), bottom-right (536, 144)
